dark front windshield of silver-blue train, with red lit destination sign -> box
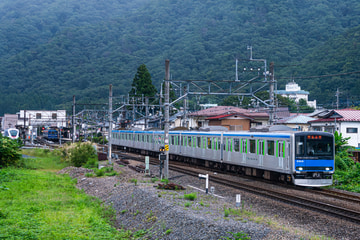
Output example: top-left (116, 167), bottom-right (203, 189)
top-left (295, 135), bottom-right (334, 159)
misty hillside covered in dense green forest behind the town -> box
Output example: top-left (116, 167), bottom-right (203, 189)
top-left (0, 0), bottom-right (360, 115)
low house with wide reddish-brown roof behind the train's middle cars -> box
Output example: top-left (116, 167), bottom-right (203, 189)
top-left (188, 106), bottom-right (269, 131)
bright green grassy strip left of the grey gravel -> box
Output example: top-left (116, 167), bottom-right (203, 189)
top-left (0, 150), bottom-right (132, 239)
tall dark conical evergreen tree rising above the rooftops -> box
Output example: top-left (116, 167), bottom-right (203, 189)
top-left (129, 64), bottom-right (157, 97)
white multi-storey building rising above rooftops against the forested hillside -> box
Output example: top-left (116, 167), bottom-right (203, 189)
top-left (276, 81), bottom-right (316, 109)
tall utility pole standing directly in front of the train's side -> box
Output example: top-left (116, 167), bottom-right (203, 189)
top-left (164, 59), bottom-right (170, 179)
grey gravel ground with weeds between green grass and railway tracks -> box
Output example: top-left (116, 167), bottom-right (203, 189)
top-left (60, 162), bottom-right (360, 240)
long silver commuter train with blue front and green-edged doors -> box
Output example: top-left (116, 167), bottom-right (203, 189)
top-left (111, 130), bottom-right (335, 187)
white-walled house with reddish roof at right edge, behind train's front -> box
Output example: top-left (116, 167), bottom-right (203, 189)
top-left (309, 109), bottom-right (360, 147)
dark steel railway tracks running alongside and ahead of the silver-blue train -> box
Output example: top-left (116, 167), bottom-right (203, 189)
top-left (114, 153), bottom-right (360, 224)
